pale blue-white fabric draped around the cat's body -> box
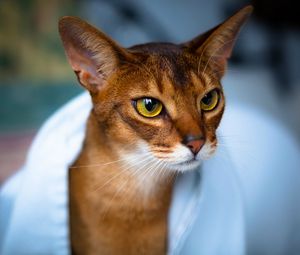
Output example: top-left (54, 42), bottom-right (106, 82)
top-left (0, 93), bottom-right (300, 255)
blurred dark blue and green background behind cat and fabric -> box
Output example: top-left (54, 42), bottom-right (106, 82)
top-left (0, 0), bottom-right (300, 184)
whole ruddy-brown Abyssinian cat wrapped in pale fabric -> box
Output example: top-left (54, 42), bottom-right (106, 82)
top-left (59, 6), bottom-right (252, 255)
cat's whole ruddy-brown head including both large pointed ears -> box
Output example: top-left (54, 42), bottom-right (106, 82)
top-left (59, 6), bottom-right (252, 171)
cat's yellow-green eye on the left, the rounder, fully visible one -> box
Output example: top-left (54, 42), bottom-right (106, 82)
top-left (136, 98), bottom-right (163, 118)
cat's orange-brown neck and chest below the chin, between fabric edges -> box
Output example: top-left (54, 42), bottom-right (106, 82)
top-left (69, 114), bottom-right (174, 255)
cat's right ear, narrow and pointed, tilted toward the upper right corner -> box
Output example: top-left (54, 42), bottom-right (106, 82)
top-left (182, 6), bottom-right (253, 78)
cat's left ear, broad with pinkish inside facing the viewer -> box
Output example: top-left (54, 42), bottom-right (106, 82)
top-left (59, 17), bottom-right (129, 92)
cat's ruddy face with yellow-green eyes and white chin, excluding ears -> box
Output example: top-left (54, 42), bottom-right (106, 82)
top-left (93, 44), bottom-right (224, 170)
